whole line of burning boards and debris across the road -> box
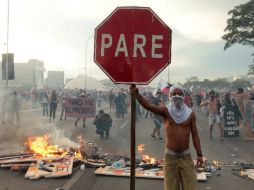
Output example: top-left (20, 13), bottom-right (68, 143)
top-left (0, 135), bottom-right (253, 181)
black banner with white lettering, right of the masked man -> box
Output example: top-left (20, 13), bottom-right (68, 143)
top-left (224, 105), bottom-right (240, 137)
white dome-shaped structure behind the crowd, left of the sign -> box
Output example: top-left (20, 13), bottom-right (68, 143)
top-left (64, 75), bottom-right (107, 91)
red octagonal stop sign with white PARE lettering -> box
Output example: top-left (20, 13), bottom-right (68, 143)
top-left (94, 7), bottom-right (171, 84)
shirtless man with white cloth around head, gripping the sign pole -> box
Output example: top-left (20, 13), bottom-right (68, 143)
top-left (130, 86), bottom-right (203, 190)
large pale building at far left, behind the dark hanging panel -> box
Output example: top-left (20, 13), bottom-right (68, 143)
top-left (0, 59), bottom-right (45, 87)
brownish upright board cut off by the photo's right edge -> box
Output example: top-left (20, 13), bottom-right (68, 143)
top-left (243, 100), bottom-right (254, 140)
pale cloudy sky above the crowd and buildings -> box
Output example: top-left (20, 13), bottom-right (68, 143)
top-left (0, 0), bottom-right (253, 83)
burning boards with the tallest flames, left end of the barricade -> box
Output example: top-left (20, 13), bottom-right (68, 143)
top-left (0, 134), bottom-right (83, 179)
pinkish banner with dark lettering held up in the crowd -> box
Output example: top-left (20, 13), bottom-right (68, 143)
top-left (65, 97), bottom-right (96, 118)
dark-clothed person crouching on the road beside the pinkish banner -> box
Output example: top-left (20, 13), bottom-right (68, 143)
top-left (93, 110), bottom-right (112, 138)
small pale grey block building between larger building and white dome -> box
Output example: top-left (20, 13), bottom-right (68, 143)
top-left (46, 71), bottom-right (64, 88)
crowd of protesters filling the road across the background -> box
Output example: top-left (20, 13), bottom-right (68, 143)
top-left (0, 85), bottom-right (254, 141)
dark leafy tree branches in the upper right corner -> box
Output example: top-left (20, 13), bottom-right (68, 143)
top-left (222, 0), bottom-right (254, 50)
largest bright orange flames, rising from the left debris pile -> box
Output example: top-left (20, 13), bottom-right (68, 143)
top-left (25, 134), bottom-right (67, 157)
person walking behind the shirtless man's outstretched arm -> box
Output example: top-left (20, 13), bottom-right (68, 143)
top-left (151, 90), bottom-right (163, 141)
